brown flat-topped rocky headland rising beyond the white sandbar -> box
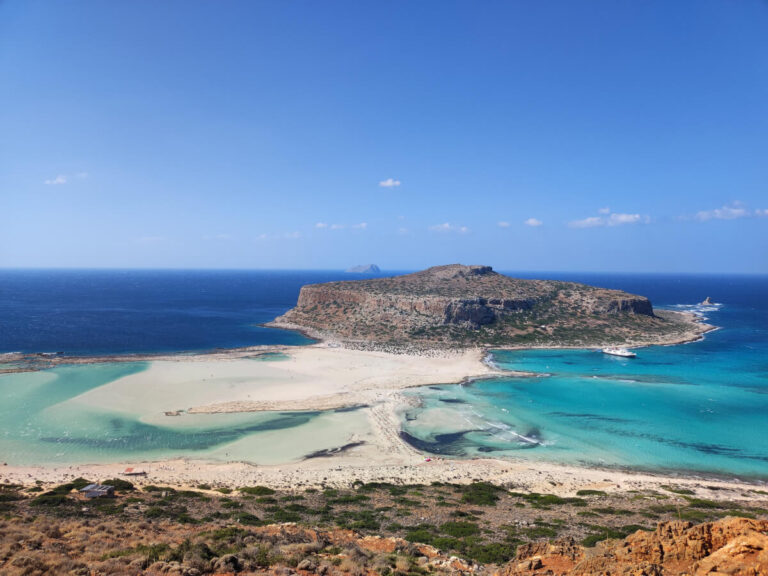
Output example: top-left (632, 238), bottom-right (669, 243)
top-left (271, 264), bottom-right (703, 348)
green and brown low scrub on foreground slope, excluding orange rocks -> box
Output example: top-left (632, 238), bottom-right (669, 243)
top-left (0, 478), bottom-right (768, 576)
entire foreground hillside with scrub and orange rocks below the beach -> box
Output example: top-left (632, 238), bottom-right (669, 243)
top-left (0, 478), bottom-right (768, 576)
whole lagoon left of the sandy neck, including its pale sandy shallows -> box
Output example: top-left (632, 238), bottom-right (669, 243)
top-left (0, 362), bottom-right (366, 465)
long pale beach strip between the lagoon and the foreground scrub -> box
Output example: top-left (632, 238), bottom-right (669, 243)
top-left (0, 452), bottom-right (768, 502)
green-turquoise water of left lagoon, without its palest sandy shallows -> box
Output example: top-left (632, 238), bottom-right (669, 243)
top-left (0, 357), bottom-right (328, 465)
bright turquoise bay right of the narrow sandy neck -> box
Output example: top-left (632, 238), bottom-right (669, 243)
top-left (404, 296), bottom-right (768, 478)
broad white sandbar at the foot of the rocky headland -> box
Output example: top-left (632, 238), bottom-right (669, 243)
top-left (70, 346), bottom-right (498, 422)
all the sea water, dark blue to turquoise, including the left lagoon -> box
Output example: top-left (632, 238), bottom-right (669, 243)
top-left (0, 270), bottom-right (768, 478)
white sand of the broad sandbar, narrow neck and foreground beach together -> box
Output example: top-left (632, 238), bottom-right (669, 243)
top-left (0, 345), bottom-right (764, 499)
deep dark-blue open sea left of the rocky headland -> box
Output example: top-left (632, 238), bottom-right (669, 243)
top-left (0, 270), bottom-right (380, 355)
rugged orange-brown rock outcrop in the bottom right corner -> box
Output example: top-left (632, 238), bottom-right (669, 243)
top-left (498, 518), bottom-right (768, 576)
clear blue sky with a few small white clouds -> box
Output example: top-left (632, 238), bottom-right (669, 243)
top-left (0, 0), bottom-right (768, 273)
